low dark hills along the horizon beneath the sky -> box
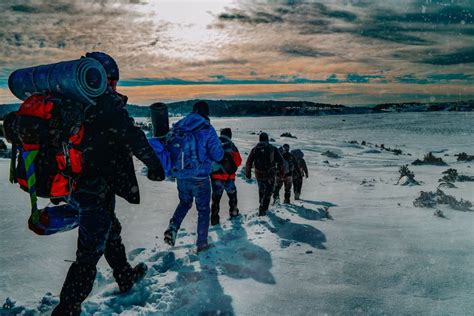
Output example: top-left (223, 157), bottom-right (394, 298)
top-left (0, 100), bottom-right (474, 120)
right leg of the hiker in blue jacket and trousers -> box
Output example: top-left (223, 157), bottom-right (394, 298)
top-left (193, 178), bottom-right (211, 249)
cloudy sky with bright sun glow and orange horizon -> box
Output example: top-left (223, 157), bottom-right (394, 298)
top-left (0, 0), bottom-right (474, 105)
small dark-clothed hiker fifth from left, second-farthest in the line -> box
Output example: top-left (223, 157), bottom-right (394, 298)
top-left (273, 144), bottom-right (296, 204)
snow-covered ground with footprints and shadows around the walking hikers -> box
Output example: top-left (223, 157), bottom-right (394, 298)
top-left (0, 113), bottom-right (474, 315)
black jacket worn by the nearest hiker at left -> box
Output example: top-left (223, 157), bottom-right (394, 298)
top-left (78, 89), bottom-right (163, 204)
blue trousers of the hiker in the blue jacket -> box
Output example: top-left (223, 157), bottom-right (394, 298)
top-left (170, 177), bottom-right (211, 247)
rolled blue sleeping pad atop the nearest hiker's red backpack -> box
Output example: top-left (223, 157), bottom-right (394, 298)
top-left (8, 58), bottom-right (107, 104)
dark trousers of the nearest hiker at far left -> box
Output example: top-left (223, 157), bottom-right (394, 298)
top-left (53, 180), bottom-right (132, 315)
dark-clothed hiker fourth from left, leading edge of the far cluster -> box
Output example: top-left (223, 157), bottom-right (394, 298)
top-left (245, 133), bottom-right (283, 216)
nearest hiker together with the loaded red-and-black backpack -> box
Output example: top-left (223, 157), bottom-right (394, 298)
top-left (5, 52), bottom-right (164, 315)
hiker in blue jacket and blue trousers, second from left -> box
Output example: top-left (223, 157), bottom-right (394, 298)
top-left (164, 101), bottom-right (224, 252)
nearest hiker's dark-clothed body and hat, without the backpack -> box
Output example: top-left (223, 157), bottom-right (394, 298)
top-left (52, 52), bottom-right (164, 315)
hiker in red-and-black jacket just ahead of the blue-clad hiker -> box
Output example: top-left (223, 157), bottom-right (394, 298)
top-left (211, 128), bottom-right (242, 226)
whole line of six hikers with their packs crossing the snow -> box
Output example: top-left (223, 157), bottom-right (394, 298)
top-left (4, 52), bottom-right (308, 315)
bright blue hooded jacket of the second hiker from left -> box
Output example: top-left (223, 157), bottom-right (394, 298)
top-left (172, 113), bottom-right (224, 179)
